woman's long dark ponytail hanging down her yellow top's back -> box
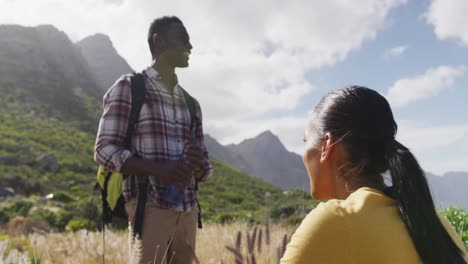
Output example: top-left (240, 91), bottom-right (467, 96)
top-left (386, 140), bottom-right (466, 264)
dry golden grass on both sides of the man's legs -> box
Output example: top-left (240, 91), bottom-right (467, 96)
top-left (0, 223), bottom-right (294, 264)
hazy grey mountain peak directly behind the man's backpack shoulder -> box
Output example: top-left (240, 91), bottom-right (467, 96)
top-left (76, 34), bottom-right (133, 92)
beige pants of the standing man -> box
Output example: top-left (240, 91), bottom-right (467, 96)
top-left (125, 198), bottom-right (198, 264)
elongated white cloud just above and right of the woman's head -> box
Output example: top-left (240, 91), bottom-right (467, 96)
top-left (387, 65), bottom-right (466, 107)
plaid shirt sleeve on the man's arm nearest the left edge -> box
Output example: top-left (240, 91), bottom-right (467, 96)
top-left (94, 76), bottom-right (132, 172)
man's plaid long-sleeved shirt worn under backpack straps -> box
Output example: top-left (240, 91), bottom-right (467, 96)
top-left (94, 67), bottom-right (213, 211)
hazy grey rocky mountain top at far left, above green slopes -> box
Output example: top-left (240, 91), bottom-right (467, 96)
top-left (0, 25), bottom-right (98, 97)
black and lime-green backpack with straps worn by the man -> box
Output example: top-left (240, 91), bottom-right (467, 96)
top-left (94, 73), bottom-right (202, 237)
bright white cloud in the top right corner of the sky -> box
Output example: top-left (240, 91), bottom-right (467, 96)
top-left (424, 0), bottom-right (468, 46)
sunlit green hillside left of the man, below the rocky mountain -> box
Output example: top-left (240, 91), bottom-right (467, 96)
top-left (0, 88), bottom-right (97, 193)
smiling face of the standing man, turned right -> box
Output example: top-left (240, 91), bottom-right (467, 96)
top-left (161, 23), bottom-right (192, 68)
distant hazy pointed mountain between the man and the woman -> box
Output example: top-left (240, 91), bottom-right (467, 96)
top-left (205, 131), bottom-right (310, 191)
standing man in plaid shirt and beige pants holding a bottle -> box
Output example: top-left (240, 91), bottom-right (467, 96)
top-left (95, 17), bottom-right (212, 264)
